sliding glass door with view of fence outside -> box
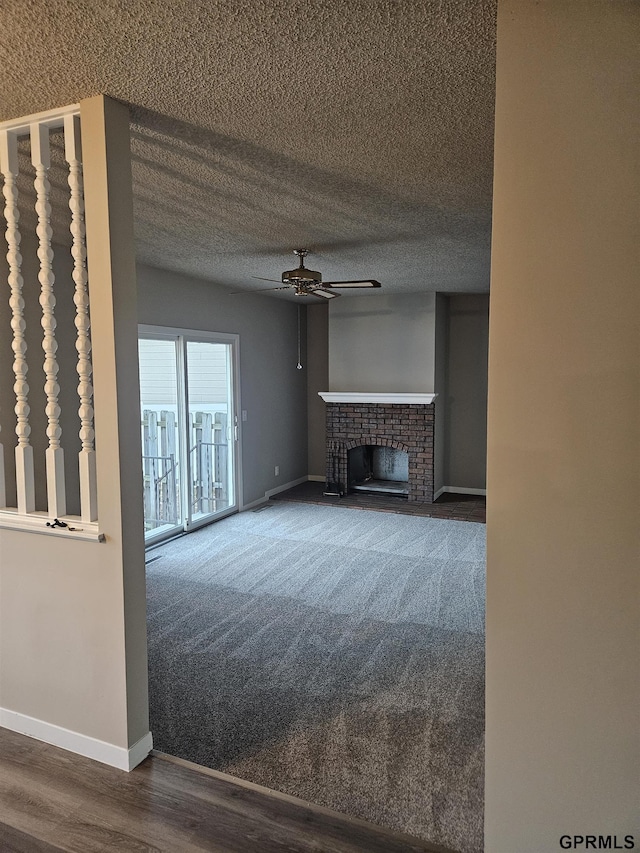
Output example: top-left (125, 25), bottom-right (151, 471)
top-left (139, 327), bottom-right (238, 544)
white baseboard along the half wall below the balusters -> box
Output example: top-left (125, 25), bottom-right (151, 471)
top-left (0, 708), bottom-right (153, 771)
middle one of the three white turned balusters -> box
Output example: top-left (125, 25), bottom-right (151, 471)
top-left (31, 124), bottom-right (67, 517)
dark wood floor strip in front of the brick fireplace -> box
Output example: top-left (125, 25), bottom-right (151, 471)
top-left (270, 481), bottom-right (487, 524)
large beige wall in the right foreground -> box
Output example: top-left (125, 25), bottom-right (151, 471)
top-left (485, 0), bottom-right (640, 853)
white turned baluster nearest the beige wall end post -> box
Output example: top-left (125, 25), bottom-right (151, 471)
top-left (64, 115), bottom-right (98, 521)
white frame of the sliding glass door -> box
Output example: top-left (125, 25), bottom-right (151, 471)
top-left (138, 323), bottom-right (244, 548)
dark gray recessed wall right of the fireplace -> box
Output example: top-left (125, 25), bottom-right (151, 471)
top-left (436, 294), bottom-right (489, 489)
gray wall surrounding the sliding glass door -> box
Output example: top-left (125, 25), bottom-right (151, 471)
top-left (138, 265), bottom-right (307, 504)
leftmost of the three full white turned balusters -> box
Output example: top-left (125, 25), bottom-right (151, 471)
top-left (0, 130), bottom-right (36, 513)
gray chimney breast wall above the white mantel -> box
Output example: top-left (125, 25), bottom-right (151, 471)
top-left (323, 290), bottom-right (436, 393)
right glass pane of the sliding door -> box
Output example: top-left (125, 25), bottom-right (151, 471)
top-left (187, 341), bottom-right (235, 522)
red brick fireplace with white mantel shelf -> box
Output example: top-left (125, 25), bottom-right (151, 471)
top-left (320, 392), bottom-right (436, 503)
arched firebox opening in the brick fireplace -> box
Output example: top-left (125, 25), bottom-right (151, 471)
top-left (347, 444), bottom-right (409, 497)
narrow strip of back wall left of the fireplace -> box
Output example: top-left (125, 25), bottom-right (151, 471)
top-left (305, 305), bottom-right (329, 480)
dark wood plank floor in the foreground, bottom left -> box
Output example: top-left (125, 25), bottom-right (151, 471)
top-left (0, 728), bottom-right (458, 853)
